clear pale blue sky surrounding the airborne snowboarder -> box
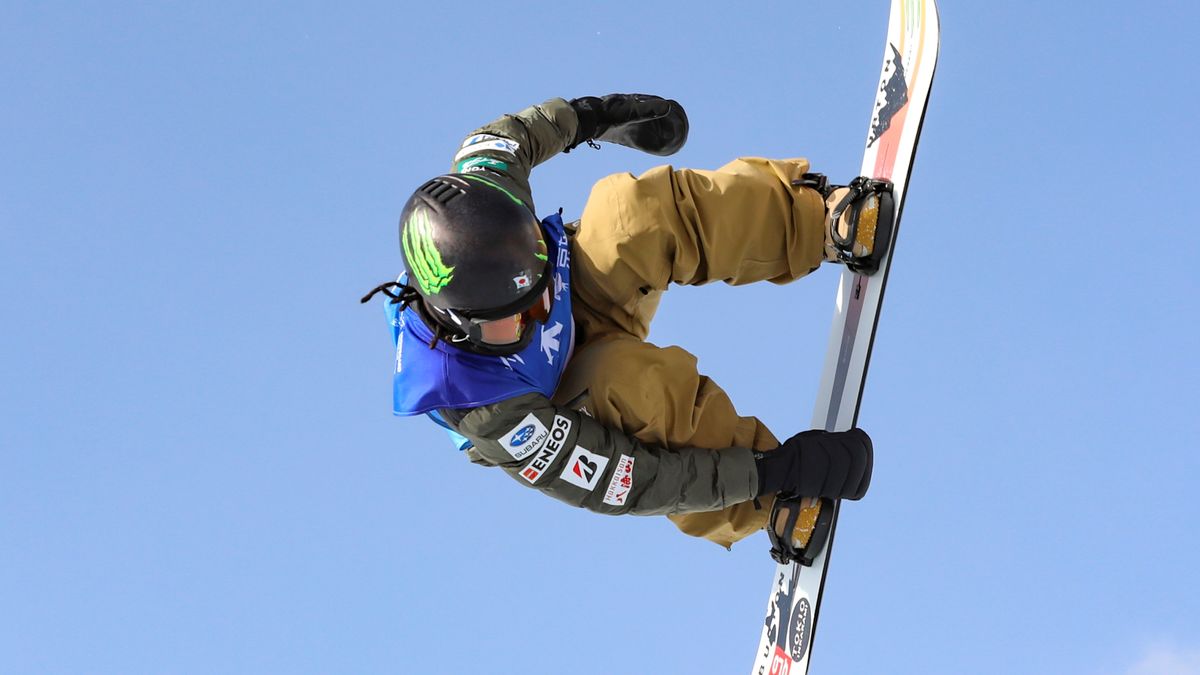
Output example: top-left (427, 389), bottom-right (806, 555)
top-left (0, 0), bottom-right (1200, 675)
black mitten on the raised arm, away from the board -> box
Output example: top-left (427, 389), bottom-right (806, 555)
top-left (566, 94), bottom-right (688, 156)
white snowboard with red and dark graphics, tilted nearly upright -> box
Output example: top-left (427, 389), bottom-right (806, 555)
top-left (751, 0), bottom-right (940, 675)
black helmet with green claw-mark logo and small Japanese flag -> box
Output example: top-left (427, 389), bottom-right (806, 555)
top-left (400, 174), bottom-right (552, 354)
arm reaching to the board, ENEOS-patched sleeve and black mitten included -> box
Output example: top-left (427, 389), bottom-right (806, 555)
top-left (439, 394), bottom-right (874, 515)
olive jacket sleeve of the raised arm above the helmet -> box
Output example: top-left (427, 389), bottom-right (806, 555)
top-left (451, 98), bottom-right (578, 213)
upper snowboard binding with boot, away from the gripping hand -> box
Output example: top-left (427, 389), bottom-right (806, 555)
top-left (792, 173), bottom-right (895, 275)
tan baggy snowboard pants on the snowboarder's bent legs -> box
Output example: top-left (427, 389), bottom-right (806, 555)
top-left (554, 157), bottom-right (824, 548)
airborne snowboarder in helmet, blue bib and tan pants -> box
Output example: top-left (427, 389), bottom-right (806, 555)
top-left (362, 94), bottom-right (892, 546)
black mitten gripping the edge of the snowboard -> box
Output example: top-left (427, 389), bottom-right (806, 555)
top-left (754, 429), bottom-right (874, 500)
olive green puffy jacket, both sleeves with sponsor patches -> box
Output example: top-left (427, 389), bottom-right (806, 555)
top-left (439, 98), bottom-right (758, 515)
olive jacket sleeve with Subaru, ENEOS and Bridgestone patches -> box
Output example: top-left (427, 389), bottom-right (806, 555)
top-left (440, 394), bottom-right (758, 515)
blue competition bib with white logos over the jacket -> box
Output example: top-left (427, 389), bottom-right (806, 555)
top-left (385, 214), bottom-right (575, 449)
